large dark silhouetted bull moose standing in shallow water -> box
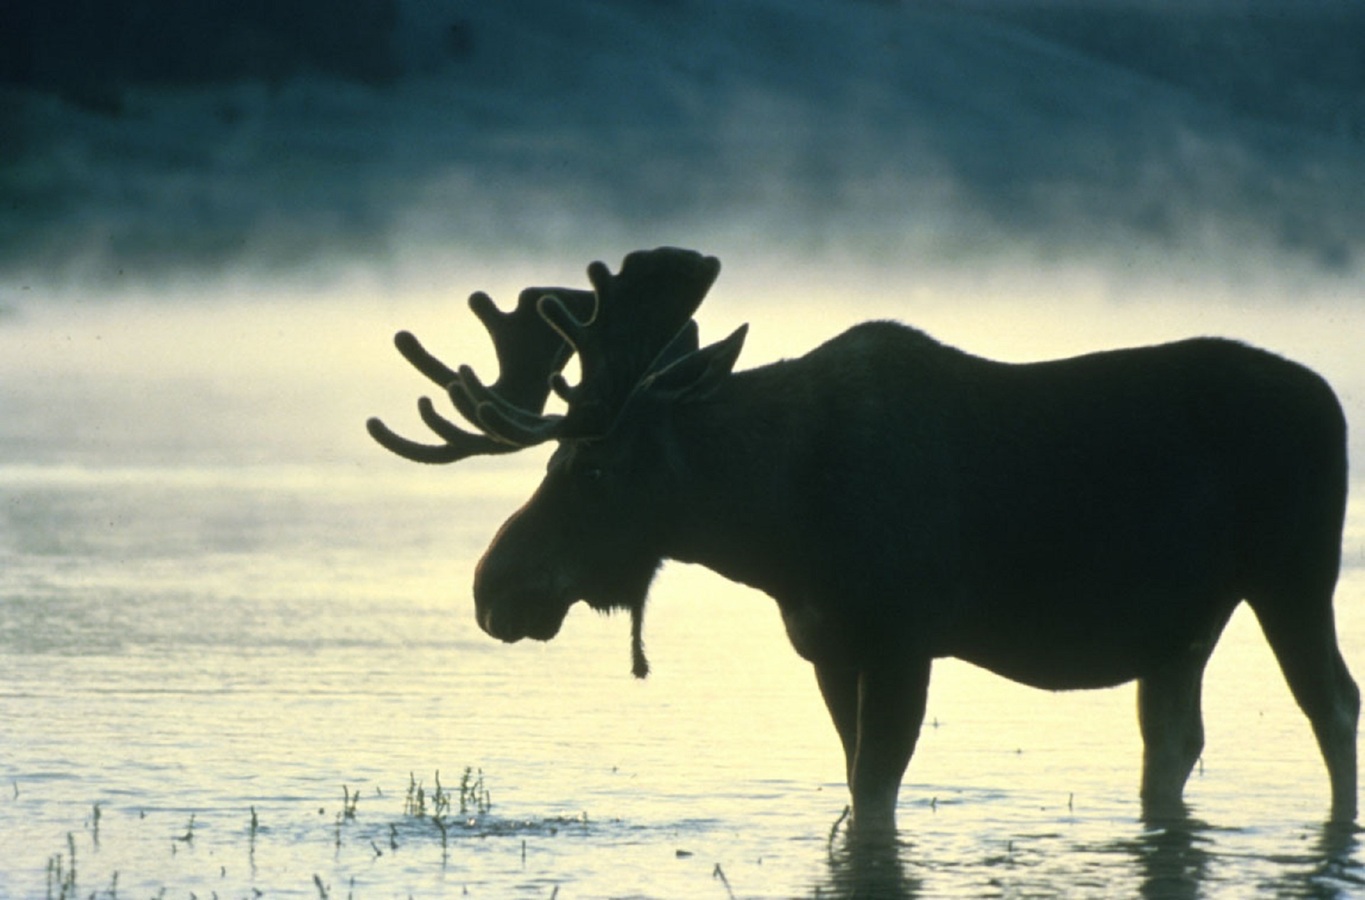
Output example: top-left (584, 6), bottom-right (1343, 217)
top-left (367, 247), bottom-right (1360, 830)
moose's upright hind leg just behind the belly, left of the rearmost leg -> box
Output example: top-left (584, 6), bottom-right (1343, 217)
top-left (1137, 647), bottom-right (1208, 818)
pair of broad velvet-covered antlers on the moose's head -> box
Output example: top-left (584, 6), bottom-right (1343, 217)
top-left (367, 247), bottom-right (721, 463)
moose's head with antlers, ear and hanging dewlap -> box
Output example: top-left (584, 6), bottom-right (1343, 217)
top-left (367, 247), bottom-right (747, 677)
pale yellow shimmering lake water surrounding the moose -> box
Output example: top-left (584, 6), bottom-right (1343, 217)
top-left (0, 269), bottom-right (1365, 897)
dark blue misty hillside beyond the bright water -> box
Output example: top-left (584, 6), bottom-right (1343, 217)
top-left (0, 0), bottom-right (1365, 292)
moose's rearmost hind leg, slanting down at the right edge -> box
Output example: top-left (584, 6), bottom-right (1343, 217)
top-left (1252, 591), bottom-right (1361, 822)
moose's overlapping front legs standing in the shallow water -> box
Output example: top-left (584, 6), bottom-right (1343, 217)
top-left (815, 658), bottom-right (930, 832)
